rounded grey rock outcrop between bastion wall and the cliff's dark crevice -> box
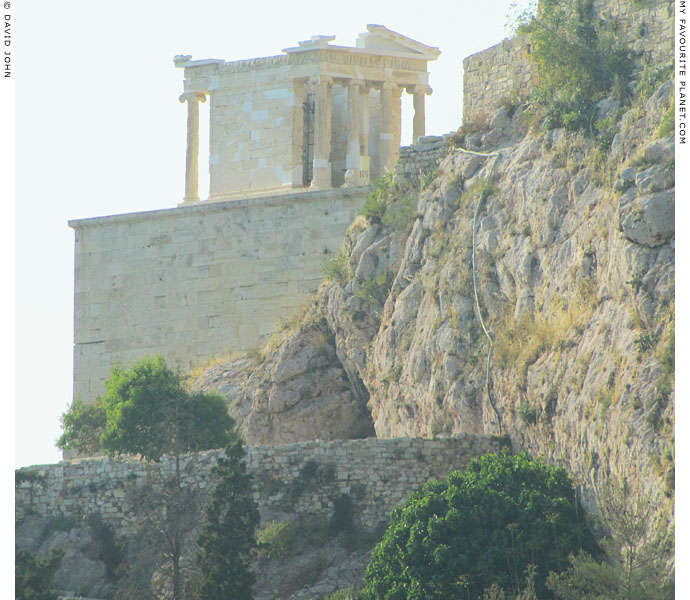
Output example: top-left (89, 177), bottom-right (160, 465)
top-left (194, 317), bottom-right (373, 444)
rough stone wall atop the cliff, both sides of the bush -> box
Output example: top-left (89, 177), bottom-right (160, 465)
top-left (462, 0), bottom-right (674, 123)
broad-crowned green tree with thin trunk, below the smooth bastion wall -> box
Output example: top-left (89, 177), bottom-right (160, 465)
top-left (58, 356), bottom-right (235, 600)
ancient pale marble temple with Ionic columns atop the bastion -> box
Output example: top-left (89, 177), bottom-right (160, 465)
top-left (174, 25), bottom-right (440, 205)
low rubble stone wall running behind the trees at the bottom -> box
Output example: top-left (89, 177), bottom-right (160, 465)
top-left (15, 434), bottom-right (507, 535)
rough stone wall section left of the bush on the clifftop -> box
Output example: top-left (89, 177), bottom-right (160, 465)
top-left (462, 34), bottom-right (539, 123)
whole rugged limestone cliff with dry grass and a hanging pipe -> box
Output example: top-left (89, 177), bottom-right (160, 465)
top-left (194, 81), bottom-right (675, 552)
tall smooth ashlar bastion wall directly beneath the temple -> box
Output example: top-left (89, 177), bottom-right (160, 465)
top-left (70, 188), bottom-right (368, 401)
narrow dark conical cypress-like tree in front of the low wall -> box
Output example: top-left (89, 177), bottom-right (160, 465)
top-left (197, 438), bottom-right (259, 600)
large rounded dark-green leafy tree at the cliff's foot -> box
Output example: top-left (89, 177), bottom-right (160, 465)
top-left (362, 453), bottom-right (595, 600)
